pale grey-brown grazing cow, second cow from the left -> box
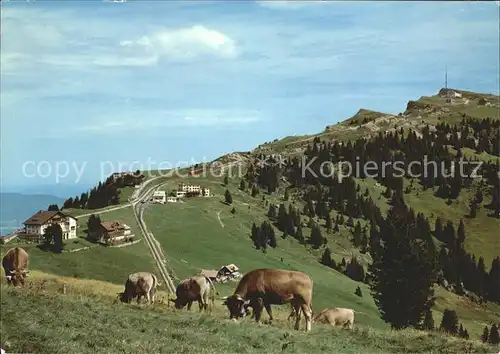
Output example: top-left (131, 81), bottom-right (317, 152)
top-left (119, 272), bottom-right (161, 303)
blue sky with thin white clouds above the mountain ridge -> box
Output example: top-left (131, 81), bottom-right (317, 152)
top-left (0, 0), bottom-right (499, 191)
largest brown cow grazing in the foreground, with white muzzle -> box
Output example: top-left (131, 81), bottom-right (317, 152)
top-left (223, 269), bottom-right (313, 332)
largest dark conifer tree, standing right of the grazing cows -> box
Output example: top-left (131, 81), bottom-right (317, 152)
top-left (369, 204), bottom-right (437, 329)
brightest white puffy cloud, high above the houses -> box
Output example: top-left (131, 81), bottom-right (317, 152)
top-left (120, 25), bottom-right (238, 60)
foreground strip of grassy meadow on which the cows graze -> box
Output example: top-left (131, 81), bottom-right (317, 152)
top-left (0, 272), bottom-right (497, 354)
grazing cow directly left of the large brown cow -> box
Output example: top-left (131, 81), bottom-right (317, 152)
top-left (170, 275), bottom-right (219, 311)
